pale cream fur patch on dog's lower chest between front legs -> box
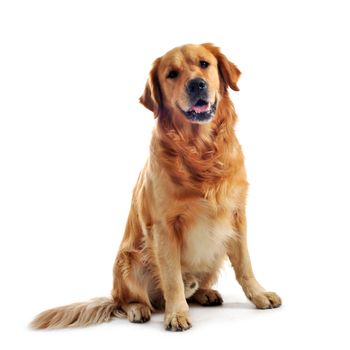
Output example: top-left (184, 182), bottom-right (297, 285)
top-left (182, 204), bottom-right (235, 273)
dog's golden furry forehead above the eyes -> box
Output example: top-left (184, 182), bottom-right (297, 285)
top-left (160, 44), bottom-right (215, 69)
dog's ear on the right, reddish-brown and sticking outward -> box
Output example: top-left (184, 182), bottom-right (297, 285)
top-left (202, 43), bottom-right (241, 91)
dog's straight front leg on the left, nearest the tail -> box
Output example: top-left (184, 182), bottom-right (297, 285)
top-left (154, 223), bottom-right (191, 331)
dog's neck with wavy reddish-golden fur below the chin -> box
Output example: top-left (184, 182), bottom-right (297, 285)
top-left (151, 94), bottom-right (241, 198)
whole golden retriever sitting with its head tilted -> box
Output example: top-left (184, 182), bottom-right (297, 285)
top-left (31, 44), bottom-right (281, 331)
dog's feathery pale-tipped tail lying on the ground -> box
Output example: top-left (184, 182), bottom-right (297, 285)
top-left (30, 298), bottom-right (125, 329)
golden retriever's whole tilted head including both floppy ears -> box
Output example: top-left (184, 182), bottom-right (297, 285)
top-left (140, 44), bottom-right (241, 123)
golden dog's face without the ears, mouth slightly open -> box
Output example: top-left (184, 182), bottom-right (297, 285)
top-left (158, 45), bottom-right (220, 123)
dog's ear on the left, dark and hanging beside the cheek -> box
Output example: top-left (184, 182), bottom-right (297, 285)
top-left (140, 58), bottom-right (162, 118)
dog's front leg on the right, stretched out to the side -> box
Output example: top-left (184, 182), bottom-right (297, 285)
top-left (227, 209), bottom-right (282, 309)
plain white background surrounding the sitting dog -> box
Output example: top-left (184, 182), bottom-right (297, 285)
top-left (0, 0), bottom-right (350, 349)
